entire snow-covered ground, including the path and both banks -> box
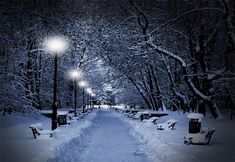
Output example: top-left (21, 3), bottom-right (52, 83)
top-left (0, 109), bottom-right (235, 162)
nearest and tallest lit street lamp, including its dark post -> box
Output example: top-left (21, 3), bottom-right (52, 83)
top-left (44, 36), bottom-right (68, 130)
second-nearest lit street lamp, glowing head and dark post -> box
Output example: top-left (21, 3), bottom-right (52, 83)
top-left (70, 70), bottom-right (82, 116)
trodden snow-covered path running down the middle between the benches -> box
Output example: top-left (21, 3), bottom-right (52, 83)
top-left (49, 110), bottom-right (148, 162)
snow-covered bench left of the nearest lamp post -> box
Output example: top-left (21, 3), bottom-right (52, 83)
top-left (29, 123), bottom-right (53, 139)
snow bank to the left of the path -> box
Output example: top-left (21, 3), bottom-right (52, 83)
top-left (0, 110), bottom-right (96, 162)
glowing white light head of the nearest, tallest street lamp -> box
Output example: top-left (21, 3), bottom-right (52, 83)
top-left (44, 36), bottom-right (68, 55)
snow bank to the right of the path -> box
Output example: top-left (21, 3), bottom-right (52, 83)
top-left (114, 112), bottom-right (235, 162)
